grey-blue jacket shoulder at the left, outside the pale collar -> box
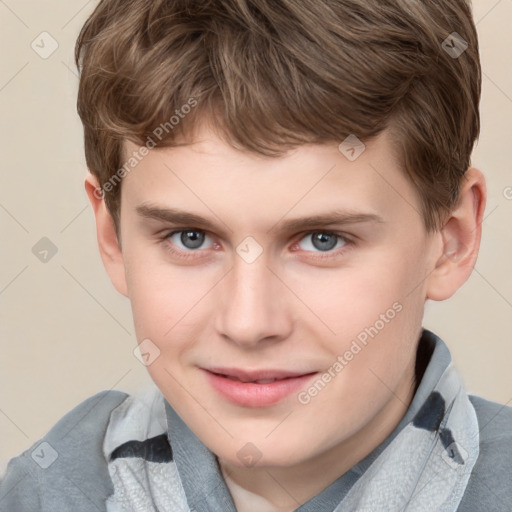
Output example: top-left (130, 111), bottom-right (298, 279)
top-left (0, 390), bottom-right (130, 512)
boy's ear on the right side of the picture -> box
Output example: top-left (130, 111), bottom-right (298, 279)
top-left (426, 168), bottom-right (487, 301)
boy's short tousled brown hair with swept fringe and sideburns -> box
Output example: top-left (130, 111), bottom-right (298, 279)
top-left (75, 0), bottom-right (481, 231)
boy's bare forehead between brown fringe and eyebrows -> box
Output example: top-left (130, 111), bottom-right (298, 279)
top-left (121, 128), bottom-right (419, 233)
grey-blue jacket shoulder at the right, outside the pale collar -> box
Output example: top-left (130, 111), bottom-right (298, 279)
top-left (459, 395), bottom-right (512, 512)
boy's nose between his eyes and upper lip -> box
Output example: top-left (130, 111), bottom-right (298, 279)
top-left (216, 253), bottom-right (293, 348)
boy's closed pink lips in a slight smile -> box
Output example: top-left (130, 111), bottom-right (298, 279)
top-left (202, 368), bottom-right (318, 407)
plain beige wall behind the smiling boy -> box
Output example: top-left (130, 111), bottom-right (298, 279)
top-left (0, 0), bottom-right (512, 471)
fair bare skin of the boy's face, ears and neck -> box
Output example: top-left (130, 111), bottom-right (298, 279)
top-left (85, 125), bottom-right (486, 512)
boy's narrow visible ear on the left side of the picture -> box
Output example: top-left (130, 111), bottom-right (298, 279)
top-left (85, 173), bottom-right (128, 297)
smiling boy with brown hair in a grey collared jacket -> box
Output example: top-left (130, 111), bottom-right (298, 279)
top-left (0, 0), bottom-right (512, 512)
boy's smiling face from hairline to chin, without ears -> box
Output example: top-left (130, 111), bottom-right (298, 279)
top-left (115, 128), bottom-right (438, 467)
